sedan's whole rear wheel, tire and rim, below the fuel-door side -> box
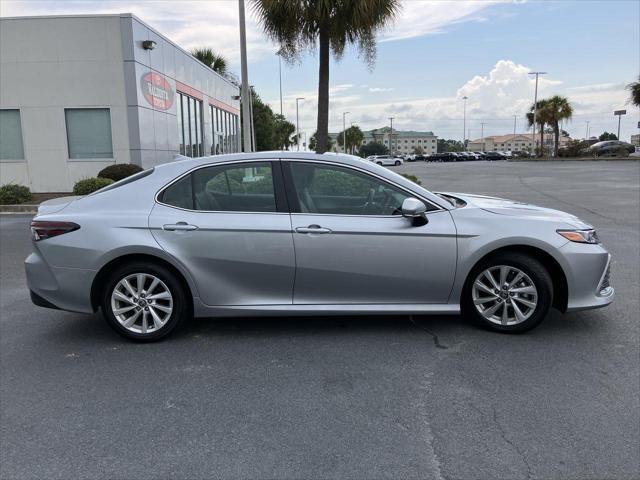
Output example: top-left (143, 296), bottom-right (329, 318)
top-left (102, 263), bottom-right (190, 342)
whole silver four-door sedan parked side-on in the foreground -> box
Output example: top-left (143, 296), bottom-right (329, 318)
top-left (25, 152), bottom-right (614, 341)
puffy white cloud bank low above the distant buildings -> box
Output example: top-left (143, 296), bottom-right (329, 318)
top-left (270, 60), bottom-right (628, 139)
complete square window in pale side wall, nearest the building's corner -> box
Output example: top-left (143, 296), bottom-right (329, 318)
top-left (64, 108), bottom-right (113, 160)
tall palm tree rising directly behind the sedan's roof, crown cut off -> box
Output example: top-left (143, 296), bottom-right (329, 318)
top-left (252, 0), bottom-right (400, 152)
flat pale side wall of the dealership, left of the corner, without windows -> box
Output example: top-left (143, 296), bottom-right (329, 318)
top-left (0, 16), bottom-right (130, 192)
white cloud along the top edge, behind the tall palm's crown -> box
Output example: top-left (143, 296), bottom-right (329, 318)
top-left (0, 0), bottom-right (513, 67)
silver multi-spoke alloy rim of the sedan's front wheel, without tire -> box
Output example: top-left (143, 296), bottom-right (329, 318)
top-left (471, 265), bottom-right (538, 326)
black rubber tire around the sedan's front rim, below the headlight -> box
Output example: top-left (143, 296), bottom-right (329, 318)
top-left (460, 252), bottom-right (553, 333)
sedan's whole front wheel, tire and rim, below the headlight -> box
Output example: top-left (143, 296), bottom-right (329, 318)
top-left (462, 253), bottom-right (553, 333)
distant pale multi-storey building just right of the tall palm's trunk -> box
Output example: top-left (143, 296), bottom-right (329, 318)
top-left (329, 127), bottom-right (438, 155)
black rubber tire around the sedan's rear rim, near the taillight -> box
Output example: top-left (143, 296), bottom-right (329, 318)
top-left (101, 262), bottom-right (193, 342)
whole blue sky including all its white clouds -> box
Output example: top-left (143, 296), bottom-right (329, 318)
top-left (0, 0), bottom-right (640, 140)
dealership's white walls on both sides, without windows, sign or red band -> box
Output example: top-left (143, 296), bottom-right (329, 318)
top-left (0, 14), bottom-right (239, 192)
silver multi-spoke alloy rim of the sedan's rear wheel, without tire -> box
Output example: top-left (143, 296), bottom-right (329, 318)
top-left (111, 273), bottom-right (173, 334)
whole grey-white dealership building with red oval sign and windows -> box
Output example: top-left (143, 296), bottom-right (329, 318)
top-left (0, 14), bottom-right (240, 192)
